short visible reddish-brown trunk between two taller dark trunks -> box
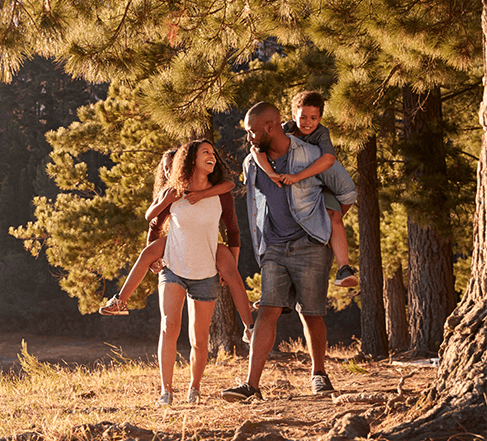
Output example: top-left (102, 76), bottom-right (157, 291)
top-left (384, 264), bottom-right (409, 353)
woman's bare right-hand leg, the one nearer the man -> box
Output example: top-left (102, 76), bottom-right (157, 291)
top-left (188, 298), bottom-right (216, 390)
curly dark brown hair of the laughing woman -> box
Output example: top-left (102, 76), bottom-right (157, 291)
top-left (168, 139), bottom-right (230, 194)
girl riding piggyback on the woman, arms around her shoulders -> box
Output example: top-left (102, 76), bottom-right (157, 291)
top-left (99, 144), bottom-right (253, 343)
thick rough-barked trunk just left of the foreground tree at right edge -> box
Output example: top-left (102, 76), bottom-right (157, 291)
top-left (403, 86), bottom-right (455, 354)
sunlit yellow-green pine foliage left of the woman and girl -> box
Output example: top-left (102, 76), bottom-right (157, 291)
top-left (10, 82), bottom-right (177, 313)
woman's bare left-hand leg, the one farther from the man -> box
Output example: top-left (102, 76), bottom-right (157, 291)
top-left (157, 283), bottom-right (186, 395)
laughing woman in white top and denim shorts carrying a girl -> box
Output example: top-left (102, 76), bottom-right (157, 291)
top-left (158, 139), bottom-right (240, 405)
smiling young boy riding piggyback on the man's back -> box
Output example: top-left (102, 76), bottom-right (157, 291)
top-left (251, 92), bottom-right (358, 288)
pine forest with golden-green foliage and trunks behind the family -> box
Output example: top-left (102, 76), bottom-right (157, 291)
top-left (0, 1), bottom-right (482, 355)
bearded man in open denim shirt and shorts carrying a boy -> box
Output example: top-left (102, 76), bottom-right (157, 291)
top-left (222, 102), bottom-right (352, 401)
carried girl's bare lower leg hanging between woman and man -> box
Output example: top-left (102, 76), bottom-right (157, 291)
top-left (216, 244), bottom-right (254, 328)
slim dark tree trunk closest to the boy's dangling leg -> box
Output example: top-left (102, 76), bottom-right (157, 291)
top-left (357, 137), bottom-right (387, 357)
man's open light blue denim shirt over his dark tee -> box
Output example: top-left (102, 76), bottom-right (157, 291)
top-left (243, 135), bottom-right (331, 266)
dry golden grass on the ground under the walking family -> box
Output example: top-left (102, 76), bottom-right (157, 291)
top-left (0, 341), bottom-right (440, 441)
